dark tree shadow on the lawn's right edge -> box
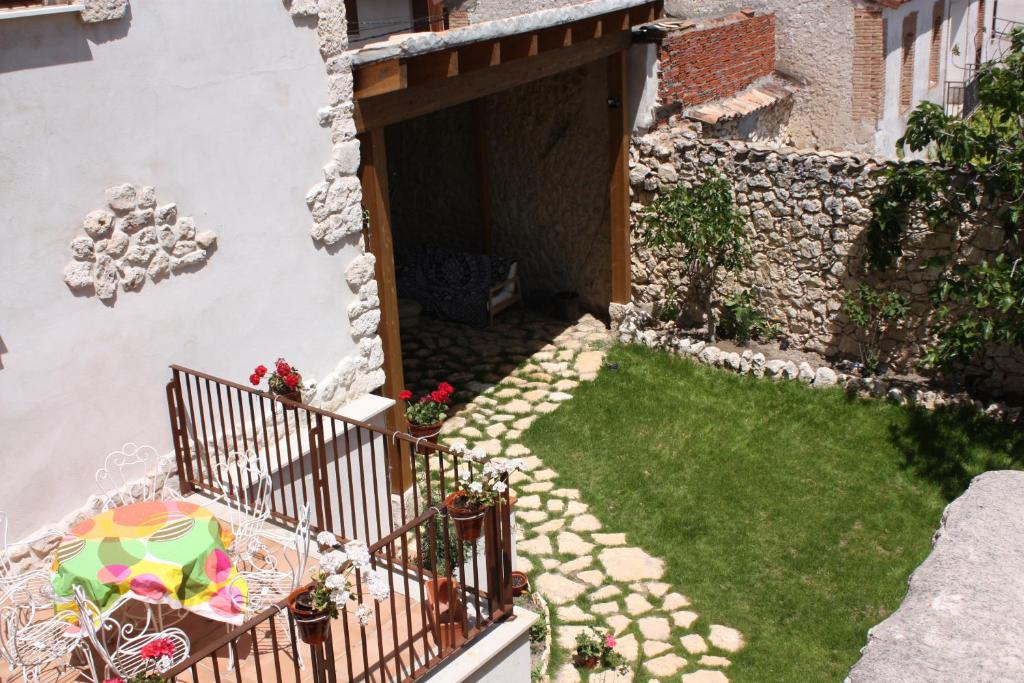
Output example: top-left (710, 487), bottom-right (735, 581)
top-left (889, 407), bottom-right (1024, 501)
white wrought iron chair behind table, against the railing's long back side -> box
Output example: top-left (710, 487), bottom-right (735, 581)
top-left (213, 451), bottom-right (273, 568)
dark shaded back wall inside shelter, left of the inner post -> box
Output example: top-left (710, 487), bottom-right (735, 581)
top-left (387, 102), bottom-right (483, 262)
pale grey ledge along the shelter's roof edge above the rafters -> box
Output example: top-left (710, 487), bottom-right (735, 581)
top-left (352, 0), bottom-right (650, 67)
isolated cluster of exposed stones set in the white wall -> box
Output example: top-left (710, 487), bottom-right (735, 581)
top-left (65, 183), bottom-right (217, 302)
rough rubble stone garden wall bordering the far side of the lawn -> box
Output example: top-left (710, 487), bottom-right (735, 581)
top-left (630, 122), bottom-right (1024, 392)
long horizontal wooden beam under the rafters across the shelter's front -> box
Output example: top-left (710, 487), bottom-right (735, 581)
top-left (354, 31), bottom-right (632, 132)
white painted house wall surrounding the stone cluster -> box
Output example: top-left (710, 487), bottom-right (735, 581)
top-left (0, 0), bottom-right (362, 537)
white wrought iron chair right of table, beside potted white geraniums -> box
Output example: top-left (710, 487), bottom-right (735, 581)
top-left (230, 503), bottom-right (312, 667)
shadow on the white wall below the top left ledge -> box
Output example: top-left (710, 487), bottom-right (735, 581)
top-left (0, 5), bottom-right (131, 74)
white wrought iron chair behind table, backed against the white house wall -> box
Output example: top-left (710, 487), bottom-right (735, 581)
top-left (96, 441), bottom-right (179, 510)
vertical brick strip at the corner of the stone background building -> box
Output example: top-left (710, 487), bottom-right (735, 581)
top-left (853, 7), bottom-right (886, 123)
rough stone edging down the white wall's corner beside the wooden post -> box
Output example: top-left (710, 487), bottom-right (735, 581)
top-left (285, 0), bottom-right (384, 411)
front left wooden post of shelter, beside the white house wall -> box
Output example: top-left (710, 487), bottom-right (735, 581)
top-left (359, 128), bottom-right (413, 494)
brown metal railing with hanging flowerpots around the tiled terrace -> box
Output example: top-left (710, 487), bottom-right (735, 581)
top-left (167, 366), bottom-right (520, 681)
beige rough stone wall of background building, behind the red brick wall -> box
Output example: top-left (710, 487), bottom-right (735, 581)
top-left (666, 0), bottom-right (874, 151)
